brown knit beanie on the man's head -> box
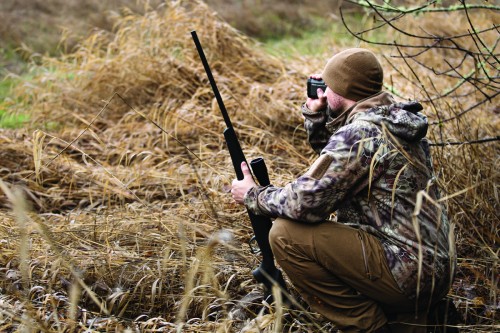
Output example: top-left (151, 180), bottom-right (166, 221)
top-left (322, 48), bottom-right (384, 102)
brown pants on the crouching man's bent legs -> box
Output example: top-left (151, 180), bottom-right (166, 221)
top-left (269, 219), bottom-right (426, 333)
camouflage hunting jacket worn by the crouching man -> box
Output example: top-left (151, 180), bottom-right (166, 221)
top-left (245, 92), bottom-right (455, 300)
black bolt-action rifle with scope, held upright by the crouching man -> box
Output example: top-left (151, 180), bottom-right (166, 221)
top-left (191, 30), bottom-right (286, 300)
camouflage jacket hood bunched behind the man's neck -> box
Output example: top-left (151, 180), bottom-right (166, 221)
top-left (346, 92), bottom-right (429, 142)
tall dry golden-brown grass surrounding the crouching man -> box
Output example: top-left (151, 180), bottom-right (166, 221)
top-left (0, 1), bottom-right (499, 332)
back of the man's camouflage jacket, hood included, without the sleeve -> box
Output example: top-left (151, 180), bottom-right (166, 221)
top-left (334, 92), bottom-right (455, 299)
